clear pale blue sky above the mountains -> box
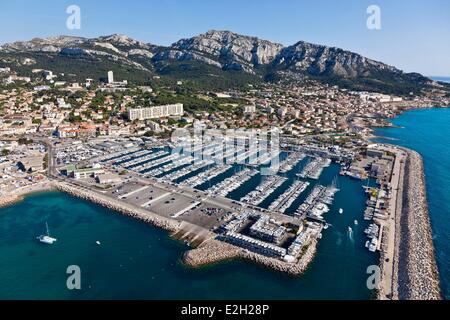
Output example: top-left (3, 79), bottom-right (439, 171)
top-left (0, 0), bottom-right (450, 76)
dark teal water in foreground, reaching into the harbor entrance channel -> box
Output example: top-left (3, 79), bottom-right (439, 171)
top-left (0, 165), bottom-right (379, 299)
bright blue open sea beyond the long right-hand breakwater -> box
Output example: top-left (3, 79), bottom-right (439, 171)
top-left (376, 108), bottom-right (450, 299)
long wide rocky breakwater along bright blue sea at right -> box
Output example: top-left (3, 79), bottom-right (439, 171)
top-left (394, 150), bottom-right (442, 300)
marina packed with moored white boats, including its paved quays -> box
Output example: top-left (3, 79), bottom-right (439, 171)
top-left (37, 135), bottom-right (400, 270)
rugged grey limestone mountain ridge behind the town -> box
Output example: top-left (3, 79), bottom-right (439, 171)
top-left (0, 30), bottom-right (442, 94)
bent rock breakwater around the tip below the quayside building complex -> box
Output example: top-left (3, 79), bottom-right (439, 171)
top-left (183, 239), bottom-right (317, 275)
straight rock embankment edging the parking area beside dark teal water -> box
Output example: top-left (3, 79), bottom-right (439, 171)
top-left (56, 182), bottom-right (181, 232)
